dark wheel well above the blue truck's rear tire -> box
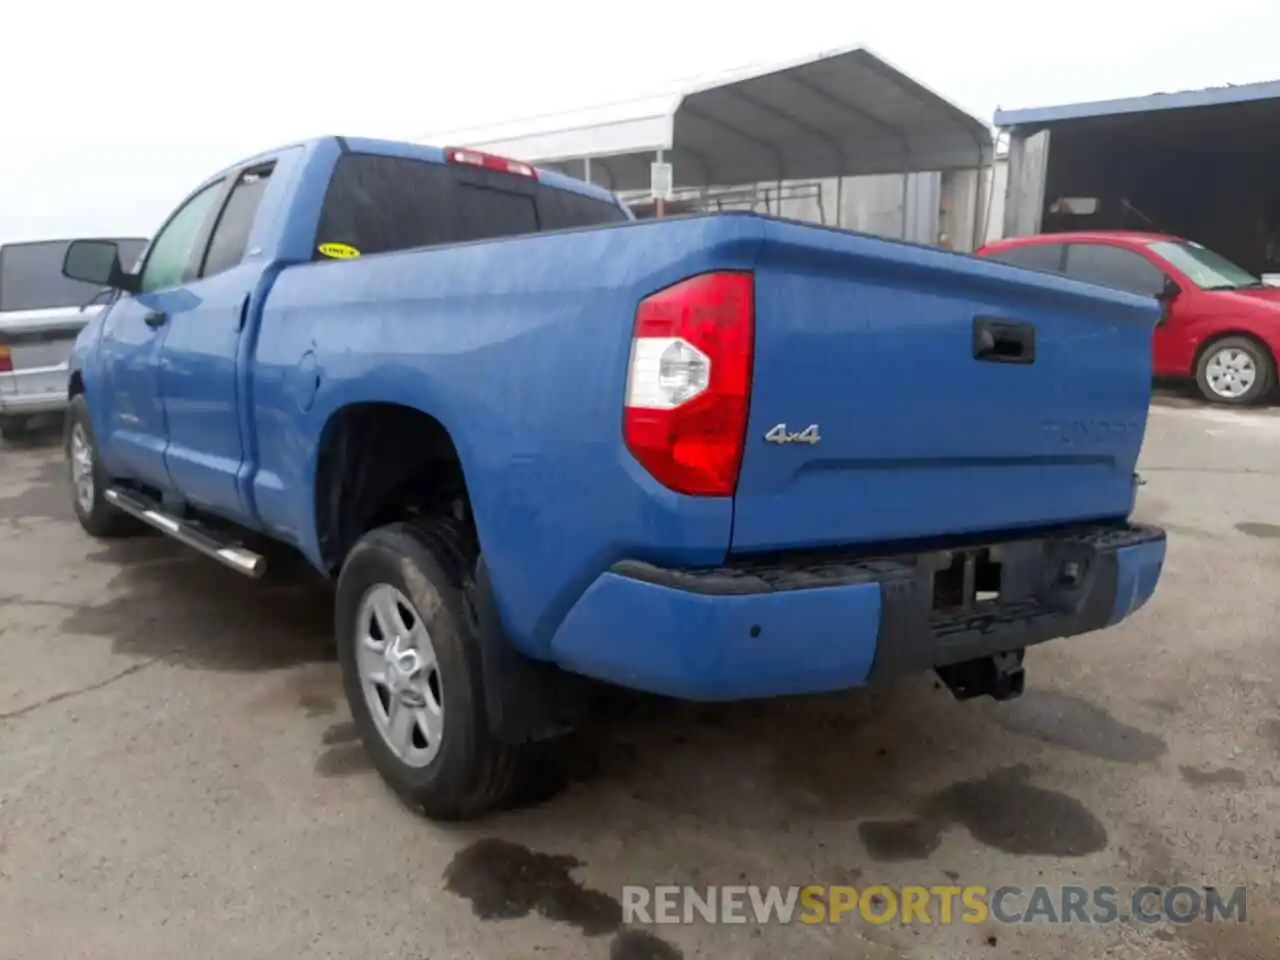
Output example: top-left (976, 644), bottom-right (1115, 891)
top-left (315, 403), bottom-right (475, 573)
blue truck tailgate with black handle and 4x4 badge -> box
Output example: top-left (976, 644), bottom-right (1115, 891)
top-left (732, 223), bottom-right (1157, 553)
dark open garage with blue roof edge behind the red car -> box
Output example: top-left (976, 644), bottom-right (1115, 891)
top-left (995, 81), bottom-right (1280, 274)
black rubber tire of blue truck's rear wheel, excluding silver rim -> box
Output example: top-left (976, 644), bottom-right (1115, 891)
top-left (335, 520), bottom-right (544, 820)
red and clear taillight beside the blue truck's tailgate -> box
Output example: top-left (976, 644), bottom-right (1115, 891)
top-left (622, 273), bottom-right (755, 497)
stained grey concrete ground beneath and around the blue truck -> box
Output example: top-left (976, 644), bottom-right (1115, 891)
top-left (0, 402), bottom-right (1280, 960)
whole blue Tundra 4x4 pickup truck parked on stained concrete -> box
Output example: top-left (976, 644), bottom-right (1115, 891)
top-left (64, 137), bottom-right (1165, 819)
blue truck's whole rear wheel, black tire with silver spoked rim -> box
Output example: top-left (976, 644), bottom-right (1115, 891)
top-left (335, 521), bottom-right (538, 820)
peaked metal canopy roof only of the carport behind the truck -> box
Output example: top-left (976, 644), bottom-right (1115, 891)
top-left (429, 47), bottom-right (992, 192)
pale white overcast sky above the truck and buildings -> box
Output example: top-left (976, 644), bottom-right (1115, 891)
top-left (0, 0), bottom-right (1280, 242)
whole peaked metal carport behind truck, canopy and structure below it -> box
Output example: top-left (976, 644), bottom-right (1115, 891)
top-left (429, 47), bottom-right (992, 247)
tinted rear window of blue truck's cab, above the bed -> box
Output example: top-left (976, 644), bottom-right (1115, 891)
top-left (314, 154), bottom-right (628, 259)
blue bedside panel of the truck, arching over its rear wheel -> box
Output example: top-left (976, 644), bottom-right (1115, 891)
top-left (252, 216), bottom-right (764, 658)
